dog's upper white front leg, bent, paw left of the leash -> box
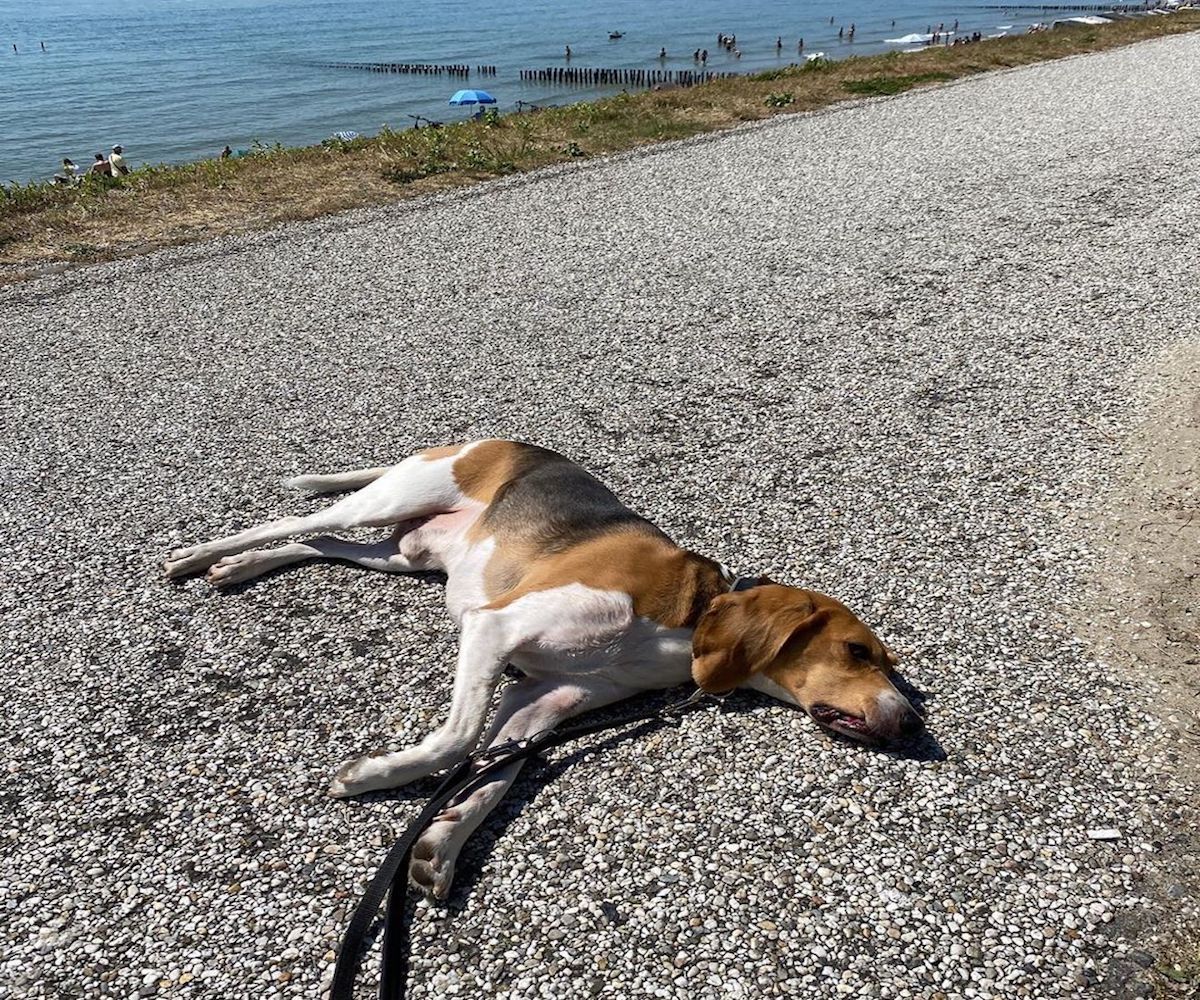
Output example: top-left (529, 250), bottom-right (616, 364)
top-left (329, 609), bottom-right (521, 798)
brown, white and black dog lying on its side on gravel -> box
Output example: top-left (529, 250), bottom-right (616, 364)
top-left (164, 441), bottom-right (923, 898)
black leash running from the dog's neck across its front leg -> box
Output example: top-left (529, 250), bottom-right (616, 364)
top-left (329, 688), bottom-right (725, 1000)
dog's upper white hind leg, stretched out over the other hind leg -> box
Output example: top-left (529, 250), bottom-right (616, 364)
top-left (163, 445), bottom-right (472, 579)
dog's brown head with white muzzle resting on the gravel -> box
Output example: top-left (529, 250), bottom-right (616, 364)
top-left (691, 583), bottom-right (924, 745)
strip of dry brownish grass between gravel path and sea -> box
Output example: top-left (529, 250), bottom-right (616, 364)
top-left (0, 11), bottom-right (1200, 282)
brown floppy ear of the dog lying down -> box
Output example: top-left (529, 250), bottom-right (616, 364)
top-left (691, 583), bottom-right (828, 693)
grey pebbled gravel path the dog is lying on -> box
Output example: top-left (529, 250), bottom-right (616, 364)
top-left (0, 36), bottom-right (1200, 1000)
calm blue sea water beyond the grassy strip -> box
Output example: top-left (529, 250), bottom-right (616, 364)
top-left (0, 0), bottom-right (1038, 181)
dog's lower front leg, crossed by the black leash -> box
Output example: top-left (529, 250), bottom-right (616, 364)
top-left (408, 677), bottom-right (636, 899)
